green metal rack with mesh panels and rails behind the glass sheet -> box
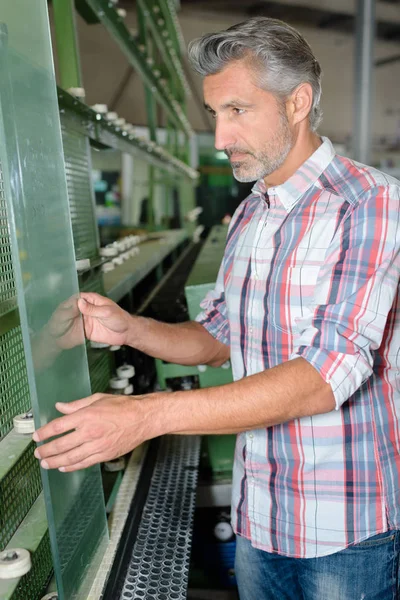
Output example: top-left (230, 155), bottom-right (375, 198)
top-left (0, 0), bottom-right (198, 600)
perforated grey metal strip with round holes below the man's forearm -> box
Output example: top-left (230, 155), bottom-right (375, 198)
top-left (120, 436), bottom-right (200, 600)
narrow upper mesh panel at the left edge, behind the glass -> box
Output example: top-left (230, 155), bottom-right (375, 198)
top-left (0, 163), bottom-right (16, 316)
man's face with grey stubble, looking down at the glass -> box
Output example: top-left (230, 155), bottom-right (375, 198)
top-left (203, 60), bottom-right (294, 182)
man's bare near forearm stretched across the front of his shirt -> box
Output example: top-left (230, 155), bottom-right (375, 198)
top-left (143, 358), bottom-right (335, 437)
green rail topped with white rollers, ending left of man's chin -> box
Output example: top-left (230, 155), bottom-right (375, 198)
top-left (58, 88), bottom-right (199, 182)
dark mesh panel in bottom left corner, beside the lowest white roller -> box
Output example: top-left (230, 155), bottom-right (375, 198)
top-left (11, 531), bottom-right (53, 600)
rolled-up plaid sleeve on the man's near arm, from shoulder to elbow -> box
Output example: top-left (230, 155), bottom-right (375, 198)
top-left (290, 185), bottom-right (400, 409)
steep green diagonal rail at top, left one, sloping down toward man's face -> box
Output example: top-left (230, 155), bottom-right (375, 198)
top-left (78, 0), bottom-right (194, 137)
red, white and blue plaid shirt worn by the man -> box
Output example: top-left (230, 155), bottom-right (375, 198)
top-left (197, 138), bottom-right (400, 558)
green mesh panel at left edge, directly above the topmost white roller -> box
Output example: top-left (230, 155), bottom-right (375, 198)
top-left (0, 326), bottom-right (30, 439)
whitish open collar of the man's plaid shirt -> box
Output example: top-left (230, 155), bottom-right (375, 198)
top-left (252, 137), bottom-right (336, 212)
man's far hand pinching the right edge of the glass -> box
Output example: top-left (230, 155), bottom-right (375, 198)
top-left (78, 293), bottom-right (132, 346)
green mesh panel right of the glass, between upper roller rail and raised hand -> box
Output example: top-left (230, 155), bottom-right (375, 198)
top-left (61, 125), bottom-right (98, 260)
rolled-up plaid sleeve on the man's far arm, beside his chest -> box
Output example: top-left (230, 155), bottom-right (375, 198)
top-left (195, 261), bottom-right (230, 346)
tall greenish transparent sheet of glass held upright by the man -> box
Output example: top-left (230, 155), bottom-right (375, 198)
top-left (0, 0), bottom-right (108, 600)
